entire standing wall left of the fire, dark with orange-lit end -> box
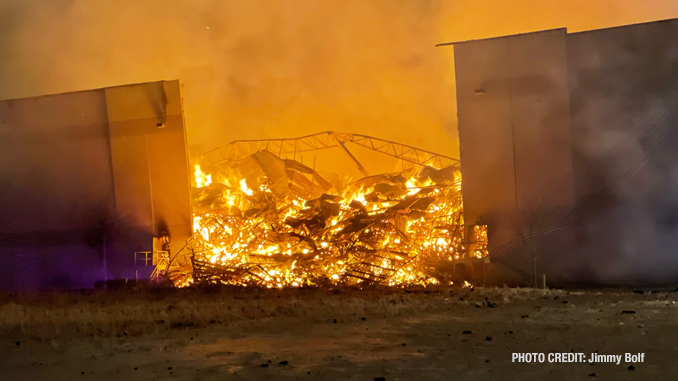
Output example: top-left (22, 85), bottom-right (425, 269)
top-left (0, 81), bottom-right (192, 290)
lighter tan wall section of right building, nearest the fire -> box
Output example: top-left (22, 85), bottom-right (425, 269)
top-left (454, 29), bottom-right (574, 279)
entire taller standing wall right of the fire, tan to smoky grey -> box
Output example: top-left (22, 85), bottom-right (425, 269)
top-left (443, 19), bottom-right (678, 284)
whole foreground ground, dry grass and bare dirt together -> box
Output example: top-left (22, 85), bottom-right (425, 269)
top-left (0, 287), bottom-right (678, 381)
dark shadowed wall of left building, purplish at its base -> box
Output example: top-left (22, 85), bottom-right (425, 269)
top-left (0, 92), bottom-right (115, 289)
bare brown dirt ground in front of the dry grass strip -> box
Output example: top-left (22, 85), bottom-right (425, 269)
top-left (0, 289), bottom-right (678, 381)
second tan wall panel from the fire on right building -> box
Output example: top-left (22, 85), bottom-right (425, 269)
top-left (508, 29), bottom-right (574, 214)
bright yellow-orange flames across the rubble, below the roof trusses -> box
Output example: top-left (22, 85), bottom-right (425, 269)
top-left (185, 156), bottom-right (487, 288)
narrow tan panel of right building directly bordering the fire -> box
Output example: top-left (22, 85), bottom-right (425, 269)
top-left (454, 39), bottom-right (516, 245)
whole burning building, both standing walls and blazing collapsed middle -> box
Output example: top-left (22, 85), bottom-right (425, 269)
top-left (5, 20), bottom-right (678, 289)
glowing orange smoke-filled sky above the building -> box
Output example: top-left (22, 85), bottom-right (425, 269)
top-left (0, 0), bottom-right (678, 157)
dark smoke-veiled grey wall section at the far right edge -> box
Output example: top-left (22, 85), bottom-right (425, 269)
top-left (567, 20), bottom-right (678, 281)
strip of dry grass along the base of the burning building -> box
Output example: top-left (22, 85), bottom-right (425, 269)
top-left (0, 287), bottom-right (563, 340)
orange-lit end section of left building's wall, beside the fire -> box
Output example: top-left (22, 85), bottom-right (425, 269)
top-left (105, 81), bottom-right (192, 268)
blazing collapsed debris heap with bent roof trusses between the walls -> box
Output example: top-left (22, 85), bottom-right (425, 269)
top-left (170, 132), bottom-right (487, 287)
